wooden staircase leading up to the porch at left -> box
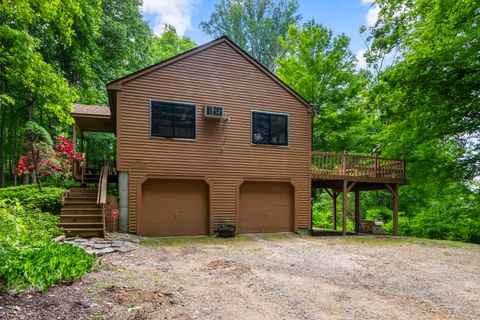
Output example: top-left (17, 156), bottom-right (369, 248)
top-left (58, 188), bottom-right (104, 237)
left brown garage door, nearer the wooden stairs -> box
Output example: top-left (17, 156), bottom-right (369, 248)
top-left (141, 179), bottom-right (209, 236)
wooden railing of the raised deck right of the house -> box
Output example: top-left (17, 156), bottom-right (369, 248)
top-left (312, 151), bottom-right (406, 181)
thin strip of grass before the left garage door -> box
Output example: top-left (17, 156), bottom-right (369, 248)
top-left (140, 235), bottom-right (247, 247)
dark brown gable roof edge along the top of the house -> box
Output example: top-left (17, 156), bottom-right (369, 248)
top-left (107, 36), bottom-right (314, 113)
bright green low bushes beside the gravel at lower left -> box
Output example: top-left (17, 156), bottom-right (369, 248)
top-left (0, 200), bottom-right (95, 291)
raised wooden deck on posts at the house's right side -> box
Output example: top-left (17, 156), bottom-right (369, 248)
top-left (312, 151), bottom-right (408, 236)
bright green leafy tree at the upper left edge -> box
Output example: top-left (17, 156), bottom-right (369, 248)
top-left (0, 0), bottom-right (75, 187)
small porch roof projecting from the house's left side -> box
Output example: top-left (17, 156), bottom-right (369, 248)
top-left (70, 104), bottom-right (114, 132)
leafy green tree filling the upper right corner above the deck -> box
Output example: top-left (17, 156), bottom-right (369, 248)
top-left (368, 0), bottom-right (480, 166)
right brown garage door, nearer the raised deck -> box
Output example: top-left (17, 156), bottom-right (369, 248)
top-left (238, 182), bottom-right (294, 233)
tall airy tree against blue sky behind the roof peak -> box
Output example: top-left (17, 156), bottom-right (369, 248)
top-left (200, 0), bottom-right (300, 71)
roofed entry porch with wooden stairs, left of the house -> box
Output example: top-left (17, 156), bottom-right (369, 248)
top-left (63, 104), bottom-right (117, 236)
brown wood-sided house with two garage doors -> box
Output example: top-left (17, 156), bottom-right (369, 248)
top-left (72, 37), bottom-right (405, 236)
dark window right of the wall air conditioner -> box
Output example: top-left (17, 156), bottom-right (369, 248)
top-left (252, 111), bottom-right (288, 146)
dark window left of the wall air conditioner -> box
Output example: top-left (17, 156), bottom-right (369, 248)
top-left (150, 101), bottom-right (196, 139)
